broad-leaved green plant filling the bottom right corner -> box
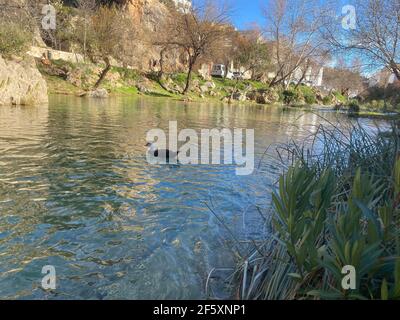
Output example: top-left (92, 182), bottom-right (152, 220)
top-left (308, 168), bottom-right (400, 299)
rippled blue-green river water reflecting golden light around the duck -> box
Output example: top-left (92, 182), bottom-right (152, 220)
top-left (0, 96), bottom-right (382, 299)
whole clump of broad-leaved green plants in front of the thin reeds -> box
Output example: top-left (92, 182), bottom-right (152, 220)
top-left (273, 161), bottom-right (400, 299)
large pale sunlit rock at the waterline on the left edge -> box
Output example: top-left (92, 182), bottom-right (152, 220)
top-left (0, 56), bottom-right (48, 105)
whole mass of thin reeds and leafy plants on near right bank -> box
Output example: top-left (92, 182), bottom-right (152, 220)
top-left (231, 119), bottom-right (400, 300)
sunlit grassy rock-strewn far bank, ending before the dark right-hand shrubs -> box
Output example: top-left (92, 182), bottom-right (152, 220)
top-left (32, 60), bottom-right (334, 106)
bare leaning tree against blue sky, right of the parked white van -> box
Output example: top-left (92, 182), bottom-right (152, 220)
top-left (264, 0), bottom-right (328, 86)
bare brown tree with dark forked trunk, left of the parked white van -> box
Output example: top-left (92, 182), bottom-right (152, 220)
top-left (155, 1), bottom-right (230, 94)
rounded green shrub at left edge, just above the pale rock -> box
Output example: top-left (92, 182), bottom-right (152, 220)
top-left (0, 22), bottom-right (32, 57)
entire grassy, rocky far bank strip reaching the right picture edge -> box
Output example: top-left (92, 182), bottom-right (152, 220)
top-left (36, 59), bottom-right (400, 119)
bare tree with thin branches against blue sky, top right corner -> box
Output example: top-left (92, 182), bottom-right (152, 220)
top-left (324, 0), bottom-right (400, 80)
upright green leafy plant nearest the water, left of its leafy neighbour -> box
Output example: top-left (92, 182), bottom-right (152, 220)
top-left (273, 166), bottom-right (335, 281)
